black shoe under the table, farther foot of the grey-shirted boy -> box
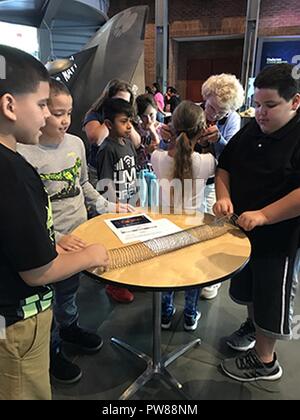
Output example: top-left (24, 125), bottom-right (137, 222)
top-left (59, 323), bottom-right (103, 353)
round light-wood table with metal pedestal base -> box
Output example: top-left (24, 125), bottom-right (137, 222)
top-left (73, 213), bottom-right (251, 400)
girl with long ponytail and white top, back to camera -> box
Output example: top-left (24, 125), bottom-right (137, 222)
top-left (151, 101), bottom-right (216, 331)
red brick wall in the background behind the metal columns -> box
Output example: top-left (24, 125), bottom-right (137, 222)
top-left (109, 0), bottom-right (300, 90)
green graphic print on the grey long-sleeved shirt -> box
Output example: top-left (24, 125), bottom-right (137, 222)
top-left (40, 158), bottom-right (82, 201)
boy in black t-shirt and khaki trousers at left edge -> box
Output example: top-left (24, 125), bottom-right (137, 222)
top-left (0, 45), bottom-right (108, 400)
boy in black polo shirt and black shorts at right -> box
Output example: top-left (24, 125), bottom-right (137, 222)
top-left (214, 64), bottom-right (300, 382)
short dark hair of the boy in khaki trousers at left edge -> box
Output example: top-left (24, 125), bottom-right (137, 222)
top-left (0, 45), bottom-right (50, 97)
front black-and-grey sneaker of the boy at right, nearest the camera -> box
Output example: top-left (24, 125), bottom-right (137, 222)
top-left (221, 349), bottom-right (282, 382)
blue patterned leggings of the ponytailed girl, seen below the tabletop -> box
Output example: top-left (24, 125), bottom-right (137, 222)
top-left (162, 287), bottom-right (201, 316)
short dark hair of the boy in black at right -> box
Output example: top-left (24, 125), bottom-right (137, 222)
top-left (254, 64), bottom-right (300, 101)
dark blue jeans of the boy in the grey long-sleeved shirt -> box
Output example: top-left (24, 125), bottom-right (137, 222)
top-left (51, 274), bottom-right (79, 353)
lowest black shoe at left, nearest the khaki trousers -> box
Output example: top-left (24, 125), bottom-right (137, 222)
top-left (50, 351), bottom-right (82, 384)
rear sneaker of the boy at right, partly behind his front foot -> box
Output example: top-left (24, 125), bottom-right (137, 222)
top-left (226, 318), bottom-right (256, 351)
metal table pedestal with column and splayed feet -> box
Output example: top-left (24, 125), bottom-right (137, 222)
top-left (111, 292), bottom-right (201, 400)
